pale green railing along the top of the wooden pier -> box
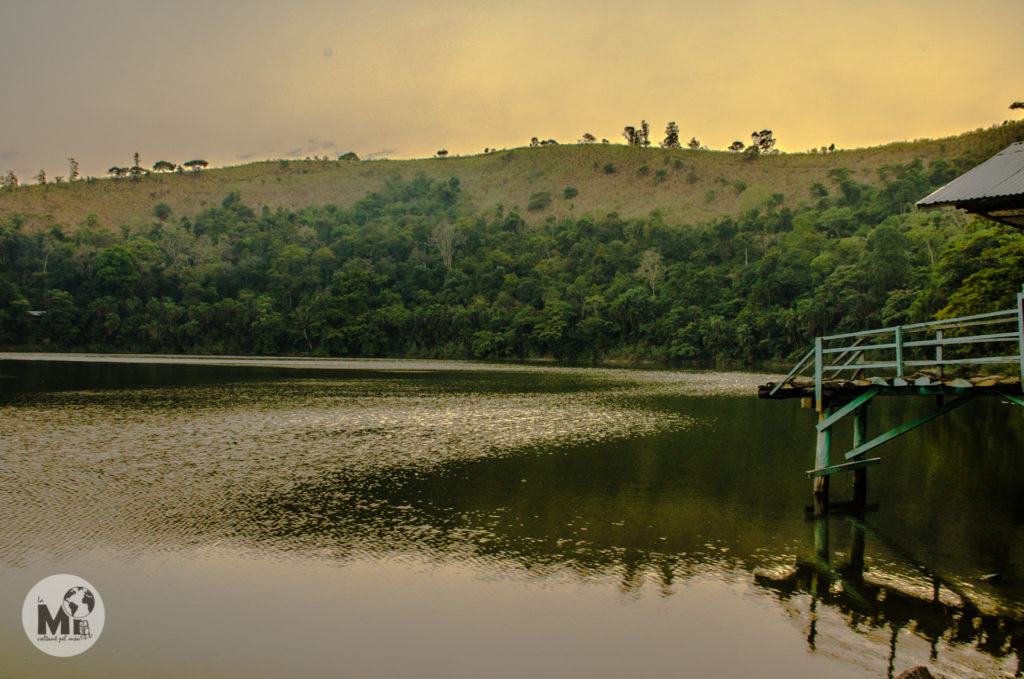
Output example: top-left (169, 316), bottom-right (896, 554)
top-left (769, 293), bottom-right (1024, 404)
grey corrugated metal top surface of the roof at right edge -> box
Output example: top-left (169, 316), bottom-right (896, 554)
top-left (918, 142), bottom-right (1024, 210)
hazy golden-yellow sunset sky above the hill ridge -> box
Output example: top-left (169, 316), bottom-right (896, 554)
top-left (0, 0), bottom-right (1024, 182)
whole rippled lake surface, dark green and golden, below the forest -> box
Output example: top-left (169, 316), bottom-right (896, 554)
top-left (0, 356), bottom-right (1024, 678)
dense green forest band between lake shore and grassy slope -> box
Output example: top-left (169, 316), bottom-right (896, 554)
top-left (0, 161), bottom-right (1024, 364)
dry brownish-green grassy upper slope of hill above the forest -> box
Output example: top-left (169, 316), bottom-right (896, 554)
top-left (6, 122), bottom-right (1024, 230)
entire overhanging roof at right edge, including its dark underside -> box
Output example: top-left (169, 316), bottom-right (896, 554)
top-left (918, 142), bottom-right (1024, 228)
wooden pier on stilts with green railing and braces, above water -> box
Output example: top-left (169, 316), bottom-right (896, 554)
top-left (758, 292), bottom-right (1024, 495)
